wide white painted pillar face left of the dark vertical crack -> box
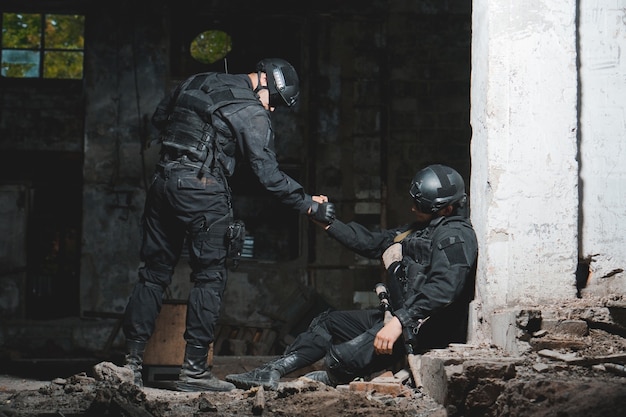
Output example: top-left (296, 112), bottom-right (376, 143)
top-left (470, 0), bottom-right (578, 340)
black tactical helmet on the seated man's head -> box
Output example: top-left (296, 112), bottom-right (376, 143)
top-left (409, 165), bottom-right (467, 213)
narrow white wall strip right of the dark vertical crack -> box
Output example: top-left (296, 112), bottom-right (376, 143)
top-left (579, 0), bottom-right (626, 296)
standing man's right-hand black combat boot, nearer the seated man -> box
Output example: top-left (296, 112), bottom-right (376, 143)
top-left (175, 345), bottom-right (235, 392)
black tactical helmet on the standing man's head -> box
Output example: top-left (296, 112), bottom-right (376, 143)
top-left (256, 58), bottom-right (300, 107)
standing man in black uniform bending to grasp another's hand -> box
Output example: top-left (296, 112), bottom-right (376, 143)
top-left (123, 58), bottom-right (327, 391)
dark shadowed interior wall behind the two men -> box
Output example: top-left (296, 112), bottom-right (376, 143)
top-left (0, 0), bottom-right (471, 352)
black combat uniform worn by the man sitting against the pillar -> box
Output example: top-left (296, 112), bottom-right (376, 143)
top-left (270, 216), bottom-right (478, 383)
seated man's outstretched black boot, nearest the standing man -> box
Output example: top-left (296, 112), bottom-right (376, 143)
top-left (224, 352), bottom-right (310, 390)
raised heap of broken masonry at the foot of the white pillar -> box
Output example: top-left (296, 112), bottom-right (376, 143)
top-left (418, 297), bottom-right (626, 417)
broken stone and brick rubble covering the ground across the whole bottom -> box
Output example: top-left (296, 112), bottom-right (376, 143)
top-left (0, 300), bottom-right (626, 417)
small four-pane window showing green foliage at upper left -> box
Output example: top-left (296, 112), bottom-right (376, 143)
top-left (0, 13), bottom-right (85, 79)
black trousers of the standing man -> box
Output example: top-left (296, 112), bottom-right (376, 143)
top-left (123, 161), bottom-right (232, 347)
